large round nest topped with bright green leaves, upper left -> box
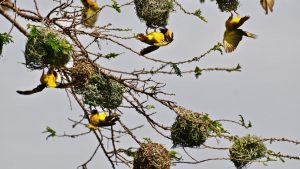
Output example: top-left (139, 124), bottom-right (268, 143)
top-left (24, 26), bottom-right (72, 70)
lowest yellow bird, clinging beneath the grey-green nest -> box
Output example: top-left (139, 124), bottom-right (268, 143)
top-left (87, 110), bottom-right (120, 130)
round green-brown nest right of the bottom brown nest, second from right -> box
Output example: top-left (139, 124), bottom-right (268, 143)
top-left (171, 108), bottom-right (209, 147)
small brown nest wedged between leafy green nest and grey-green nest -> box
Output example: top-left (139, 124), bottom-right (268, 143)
top-left (71, 58), bottom-right (96, 87)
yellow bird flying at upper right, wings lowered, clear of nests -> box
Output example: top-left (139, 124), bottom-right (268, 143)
top-left (223, 13), bottom-right (257, 53)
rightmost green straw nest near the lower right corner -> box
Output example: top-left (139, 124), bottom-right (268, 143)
top-left (229, 135), bottom-right (267, 169)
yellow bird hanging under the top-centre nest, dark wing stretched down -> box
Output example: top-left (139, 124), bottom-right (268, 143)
top-left (136, 28), bottom-right (174, 55)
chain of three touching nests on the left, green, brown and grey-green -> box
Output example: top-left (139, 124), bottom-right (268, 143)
top-left (24, 26), bottom-right (124, 109)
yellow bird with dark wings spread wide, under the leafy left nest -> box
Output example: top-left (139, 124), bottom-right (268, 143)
top-left (17, 68), bottom-right (76, 95)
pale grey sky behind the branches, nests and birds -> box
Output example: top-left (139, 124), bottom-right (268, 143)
top-left (0, 0), bottom-right (300, 169)
